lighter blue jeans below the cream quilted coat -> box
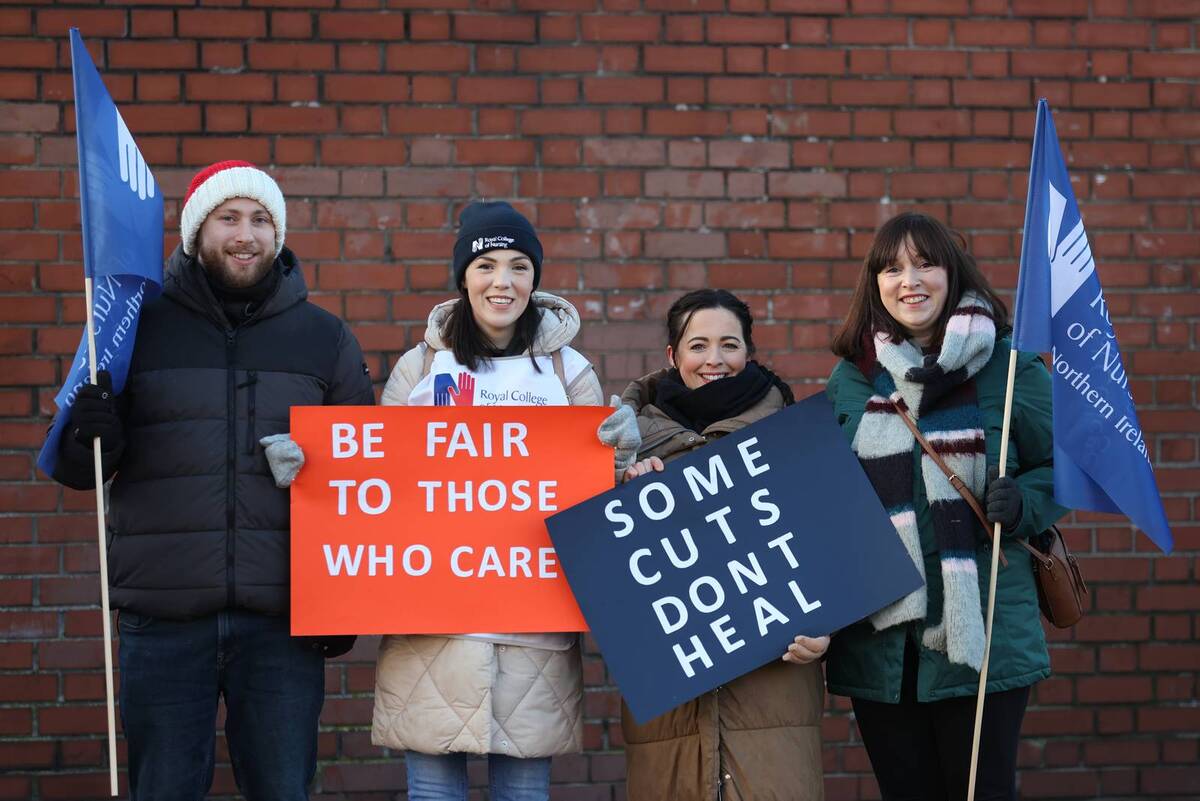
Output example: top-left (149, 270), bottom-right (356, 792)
top-left (404, 751), bottom-right (550, 801)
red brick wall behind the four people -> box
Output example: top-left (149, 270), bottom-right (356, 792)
top-left (0, 0), bottom-right (1200, 801)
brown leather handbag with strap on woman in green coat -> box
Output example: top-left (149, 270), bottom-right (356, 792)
top-left (893, 404), bottom-right (1087, 628)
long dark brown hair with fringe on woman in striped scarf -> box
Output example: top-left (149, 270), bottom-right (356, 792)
top-left (832, 211), bottom-right (1008, 361)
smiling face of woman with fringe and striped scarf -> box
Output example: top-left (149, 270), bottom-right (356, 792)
top-left (876, 231), bottom-right (949, 347)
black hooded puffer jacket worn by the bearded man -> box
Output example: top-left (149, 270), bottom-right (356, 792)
top-left (54, 248), bottom-right (374, 619)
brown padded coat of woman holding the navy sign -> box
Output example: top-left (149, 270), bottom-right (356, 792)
top-left (622, 371), bottom-right (824, 801)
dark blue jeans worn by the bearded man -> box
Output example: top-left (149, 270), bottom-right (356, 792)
top-left (118, 609), bottom-right (325, 801)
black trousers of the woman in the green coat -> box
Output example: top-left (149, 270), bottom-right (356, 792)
top-left (853, 643), bottom-right (1030, 801)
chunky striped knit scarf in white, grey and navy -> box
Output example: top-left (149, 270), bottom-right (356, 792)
top-left (852, 293), bottom-right (996, 670)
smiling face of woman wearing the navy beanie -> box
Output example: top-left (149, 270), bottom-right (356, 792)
top-left (463, 251), bottom-right (534, 348)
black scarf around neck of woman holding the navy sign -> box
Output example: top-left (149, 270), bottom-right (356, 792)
top-left (654, 361), bottom-right (794, 434)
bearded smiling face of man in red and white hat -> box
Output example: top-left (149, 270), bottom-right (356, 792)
top-left (197, 198), bottom-right (275, 289)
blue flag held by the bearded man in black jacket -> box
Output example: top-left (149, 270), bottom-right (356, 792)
top-left (37, 28), bottom-right (163, 475)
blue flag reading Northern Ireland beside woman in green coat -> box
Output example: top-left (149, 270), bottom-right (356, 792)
top-left (1013, 100), bottom-right (1174, 553)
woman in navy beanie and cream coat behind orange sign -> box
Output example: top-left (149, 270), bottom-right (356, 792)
top-left (371, 201), bottom-right (637, 801)
